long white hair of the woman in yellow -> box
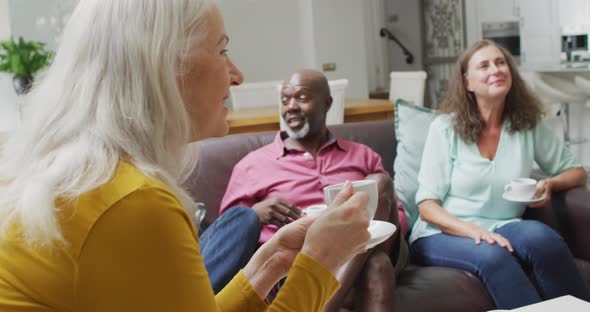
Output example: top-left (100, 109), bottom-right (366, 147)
top-left (0, 0), bottom-right (212, 245)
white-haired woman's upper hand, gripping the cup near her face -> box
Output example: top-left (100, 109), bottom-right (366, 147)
top-left (301, 182), bottom-right (371, 273)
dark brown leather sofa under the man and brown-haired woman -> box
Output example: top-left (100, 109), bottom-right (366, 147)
top-left (187, 121), bottom-right (590, 312)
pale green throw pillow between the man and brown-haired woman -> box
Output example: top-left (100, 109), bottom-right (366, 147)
top-left (393, 99), bottom-right (435, 231)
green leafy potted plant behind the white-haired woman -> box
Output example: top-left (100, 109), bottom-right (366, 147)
top-left (0, 37), bottom-right (52, 95)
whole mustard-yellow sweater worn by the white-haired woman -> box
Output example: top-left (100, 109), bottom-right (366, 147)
top-left (0, 162), bottom-right (339, 312)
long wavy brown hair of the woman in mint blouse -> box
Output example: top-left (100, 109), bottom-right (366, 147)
top-left (439, 40), bottom-right (544, 142)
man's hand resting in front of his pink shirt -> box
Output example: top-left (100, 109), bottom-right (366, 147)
top-left (252, 197), bottom-right (301, 228)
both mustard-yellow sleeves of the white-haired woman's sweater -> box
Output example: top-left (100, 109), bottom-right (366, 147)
top-left (74, 187), bottom-right (339, 312)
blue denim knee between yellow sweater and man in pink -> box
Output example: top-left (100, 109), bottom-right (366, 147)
top-left (199, 207), bottom-right (262, 294)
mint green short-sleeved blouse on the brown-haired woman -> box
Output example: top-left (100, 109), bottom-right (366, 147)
top-left (410, 114), bottom-right (580, 243)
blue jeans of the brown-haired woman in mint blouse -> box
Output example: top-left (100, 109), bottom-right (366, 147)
top-left (411, 220), bottom-right (590, 309)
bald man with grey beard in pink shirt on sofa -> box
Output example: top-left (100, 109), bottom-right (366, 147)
top-left (201, 69), bottom-right (399, 311)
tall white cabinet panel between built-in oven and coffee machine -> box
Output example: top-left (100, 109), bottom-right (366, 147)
top-left (517, 0), bottom-right (561, 68)
